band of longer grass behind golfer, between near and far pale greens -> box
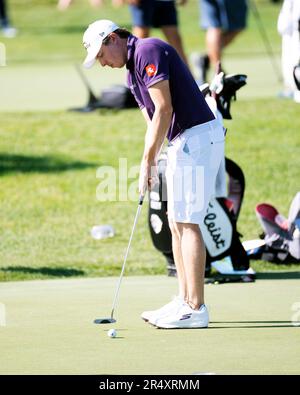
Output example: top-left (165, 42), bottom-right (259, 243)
top-left (0, 99), bottom-right (300, 281)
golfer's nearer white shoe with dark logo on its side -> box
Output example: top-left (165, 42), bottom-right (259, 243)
top-left (149, 303), bottom-right (209, 329)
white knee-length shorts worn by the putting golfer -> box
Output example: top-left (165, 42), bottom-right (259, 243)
top-left (166, 119), bottom-right (225, 224)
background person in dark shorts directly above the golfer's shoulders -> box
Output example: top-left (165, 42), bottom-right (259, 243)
top-left (114, 0), bottom-right (188, 64)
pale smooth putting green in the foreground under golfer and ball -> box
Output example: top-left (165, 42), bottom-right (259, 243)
top-left (0, 273), bottom-right (300, 375)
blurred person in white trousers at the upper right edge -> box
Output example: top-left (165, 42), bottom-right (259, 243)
top-left (277, 0), bottom-right (300, 98)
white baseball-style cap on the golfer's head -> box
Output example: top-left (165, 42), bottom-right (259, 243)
top-left (82, 19), bottom-right (119, 69)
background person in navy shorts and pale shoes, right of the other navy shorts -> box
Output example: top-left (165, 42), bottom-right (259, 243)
top-left (192, 0), bottom-right (248, 84)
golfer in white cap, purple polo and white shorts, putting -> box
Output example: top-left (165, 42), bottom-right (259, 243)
top-left (83, 20), bottom-right (224, 328)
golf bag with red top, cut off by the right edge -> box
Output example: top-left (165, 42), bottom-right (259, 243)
top-left (249, 192), bottom-right (300, 263)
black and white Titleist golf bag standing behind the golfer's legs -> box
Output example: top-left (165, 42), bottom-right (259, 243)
top-left (148, 156), bottom-right (253, 277)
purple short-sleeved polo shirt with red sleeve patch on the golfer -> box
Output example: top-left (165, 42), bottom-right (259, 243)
top-left (126, 35), bottom-right (215, 141)
